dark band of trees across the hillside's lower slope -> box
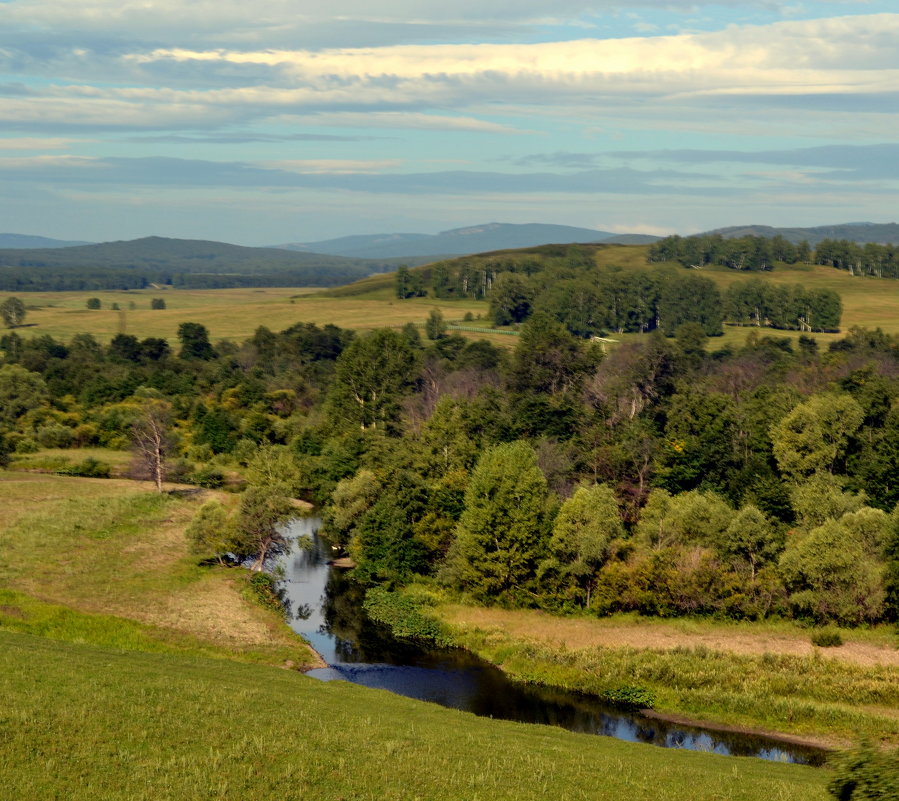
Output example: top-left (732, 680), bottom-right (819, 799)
top-left (408, 242), bottom-right (842, 337)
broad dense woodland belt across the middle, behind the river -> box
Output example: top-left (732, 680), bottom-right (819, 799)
top-left (0, 311), bottom-right (899, 625)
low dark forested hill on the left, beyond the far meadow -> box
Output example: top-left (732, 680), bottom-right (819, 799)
top-left (0, 236), bottom-right (404, 291)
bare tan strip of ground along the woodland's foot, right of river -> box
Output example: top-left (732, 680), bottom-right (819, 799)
top-left (440, 605), bottom-right (899, 668)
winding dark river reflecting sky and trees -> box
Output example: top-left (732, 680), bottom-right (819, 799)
top-left (282, 518), bottom-right (824, 765)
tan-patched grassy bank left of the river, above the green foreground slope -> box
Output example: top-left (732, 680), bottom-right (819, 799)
top-left (0, 473), bottom-right (317, 665)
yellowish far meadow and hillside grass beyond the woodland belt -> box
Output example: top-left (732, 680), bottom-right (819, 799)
top-left (8, 245), bottom-right (899, 349)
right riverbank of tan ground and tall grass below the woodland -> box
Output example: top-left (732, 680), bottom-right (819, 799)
top-left (428, 602), bottom-right (899, 748)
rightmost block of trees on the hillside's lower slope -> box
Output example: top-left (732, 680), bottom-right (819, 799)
top-left (724, 279), bottom-right (843, 331)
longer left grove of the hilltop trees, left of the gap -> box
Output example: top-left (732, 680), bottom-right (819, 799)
top-left (648, 234), bottom-right (812, 271)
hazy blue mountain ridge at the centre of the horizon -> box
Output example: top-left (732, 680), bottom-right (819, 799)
top-left (277, 223), bottom-right (658, 259)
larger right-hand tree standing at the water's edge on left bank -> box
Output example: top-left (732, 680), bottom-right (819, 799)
top-left (234, 485), bottom-right (297, 570)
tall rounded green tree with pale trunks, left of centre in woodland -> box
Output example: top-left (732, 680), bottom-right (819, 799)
top-left (328, 328), bottom-right (418, 431)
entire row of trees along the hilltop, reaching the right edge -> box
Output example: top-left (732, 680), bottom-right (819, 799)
top-left (647, 234), bottom-right (899, 278)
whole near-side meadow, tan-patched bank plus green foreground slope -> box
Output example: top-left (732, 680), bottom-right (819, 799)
top-left (0, 472), bottom-right (828, 801)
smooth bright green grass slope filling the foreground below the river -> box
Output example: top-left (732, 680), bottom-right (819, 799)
top-left (0, 632), bottom-right (827, 801)
